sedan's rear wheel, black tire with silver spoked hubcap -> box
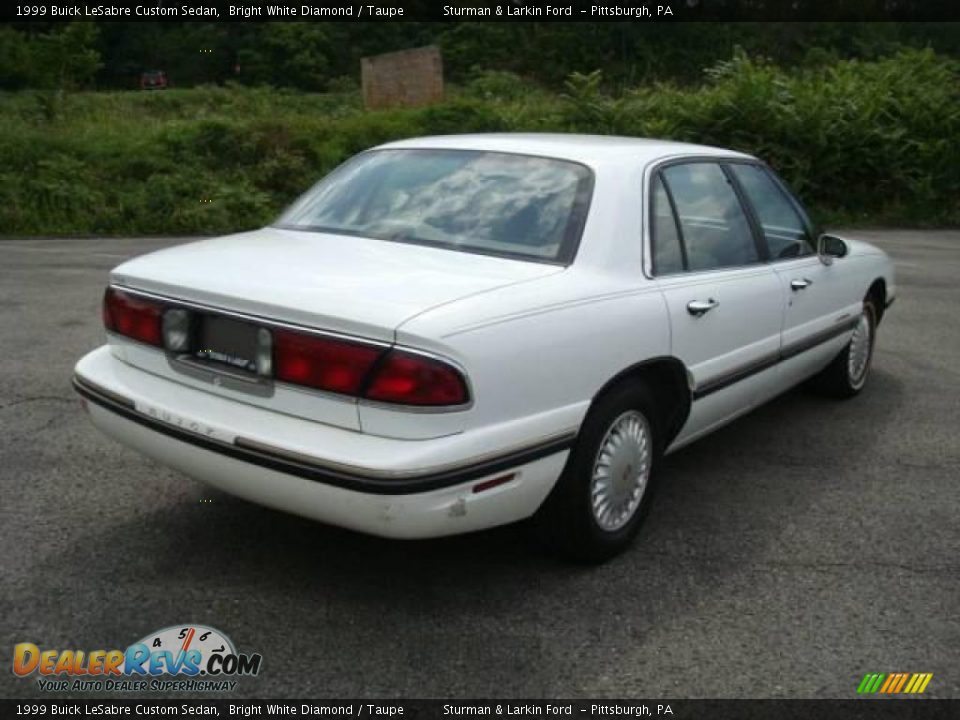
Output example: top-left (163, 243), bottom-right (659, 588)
top-left (534, 382), bottom-right (661, 563)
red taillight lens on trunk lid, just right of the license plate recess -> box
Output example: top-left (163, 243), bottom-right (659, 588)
top-left (273, 330), bottom-right (383, 395)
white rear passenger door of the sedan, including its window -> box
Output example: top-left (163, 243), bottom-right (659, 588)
top-left (648, 159), bottom-right (783, 447)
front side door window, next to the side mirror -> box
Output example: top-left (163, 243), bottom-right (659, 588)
top-left (730, 163), bottom-right (814, 260)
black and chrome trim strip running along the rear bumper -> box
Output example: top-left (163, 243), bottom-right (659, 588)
top-left (73, 375), bottom-right (576, 495)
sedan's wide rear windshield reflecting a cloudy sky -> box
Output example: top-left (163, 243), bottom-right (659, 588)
top-left (276, 150), bottom-right (593, 263)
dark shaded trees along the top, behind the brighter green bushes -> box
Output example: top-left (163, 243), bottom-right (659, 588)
top-left (0, 20), bottom-right (960, 90)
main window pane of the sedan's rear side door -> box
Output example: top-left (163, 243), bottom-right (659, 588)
top-left (661, 162), bottom-right (760, 271)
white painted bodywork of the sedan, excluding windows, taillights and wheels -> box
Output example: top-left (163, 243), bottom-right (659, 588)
top-left (76, 135), bottom-right (895, 537)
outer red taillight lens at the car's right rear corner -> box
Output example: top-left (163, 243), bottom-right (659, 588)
top-left (364, 350), bottom-right (467, 405)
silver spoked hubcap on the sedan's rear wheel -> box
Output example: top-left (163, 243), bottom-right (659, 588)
top-left (590, 410), bottom-right (651, 532)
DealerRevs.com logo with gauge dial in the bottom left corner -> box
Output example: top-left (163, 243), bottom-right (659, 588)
top-left (13, 624), bottom-right (263, 692)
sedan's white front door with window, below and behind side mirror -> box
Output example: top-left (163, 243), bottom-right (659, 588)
top-left (728, 163), bottom-right (861, 387)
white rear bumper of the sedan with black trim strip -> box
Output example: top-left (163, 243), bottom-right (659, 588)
top-left (74, 346), bottom-right (573, 538)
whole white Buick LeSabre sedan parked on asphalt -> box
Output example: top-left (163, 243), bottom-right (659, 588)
top-left (74, 135), bottom-right (895, 560)
